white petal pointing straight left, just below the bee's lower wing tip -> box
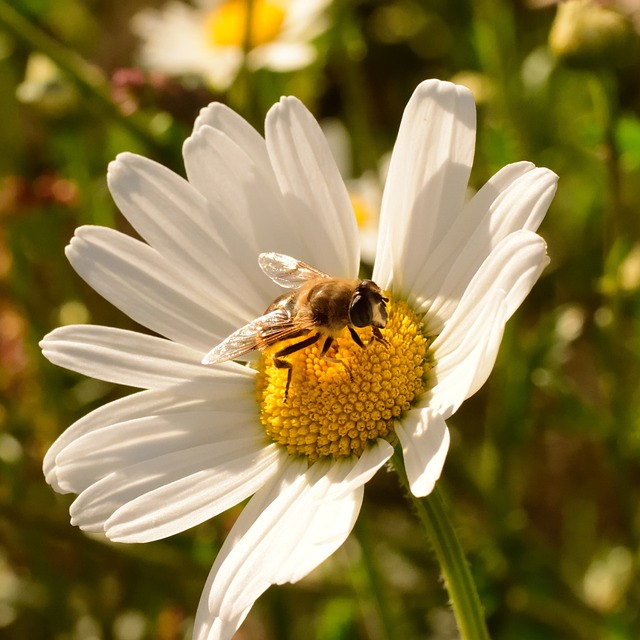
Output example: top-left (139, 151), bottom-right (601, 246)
top-left (40, 325), bottom-right (255, 397)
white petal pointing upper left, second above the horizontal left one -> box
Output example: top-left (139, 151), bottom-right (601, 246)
top-left (107, 153), bottom-right (265, 322)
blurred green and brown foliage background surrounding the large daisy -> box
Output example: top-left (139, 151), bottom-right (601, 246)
top-left (0, 0), bottom-right (640, 640)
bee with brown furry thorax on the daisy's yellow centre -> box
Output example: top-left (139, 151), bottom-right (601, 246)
top-left (202, 253), bottom-right (389, 402)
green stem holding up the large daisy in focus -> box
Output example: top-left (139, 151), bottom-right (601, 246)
top-left (392, 450), bottom-right (489, 640)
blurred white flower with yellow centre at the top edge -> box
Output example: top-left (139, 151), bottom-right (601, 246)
top-left (131, 0), bottom-right (330, 91)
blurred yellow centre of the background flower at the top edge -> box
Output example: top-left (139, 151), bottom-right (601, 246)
top-left (205, 0), bottom-right (285, 49)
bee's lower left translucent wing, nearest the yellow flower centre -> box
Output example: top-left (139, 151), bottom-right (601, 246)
top-left (202, 309), bottom-right (292, 364)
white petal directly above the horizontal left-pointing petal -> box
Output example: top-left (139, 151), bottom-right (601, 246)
top-left (66, 227), bottom-right (242, 351)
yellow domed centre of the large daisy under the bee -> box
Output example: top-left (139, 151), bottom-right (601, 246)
top-left (257, 300), bottom-right (434, 461)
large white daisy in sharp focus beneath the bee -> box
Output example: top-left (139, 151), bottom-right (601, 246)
top-left (42, 80), bottom-right (556, 640)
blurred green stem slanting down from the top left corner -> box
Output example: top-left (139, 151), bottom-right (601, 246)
top-left (0, 0), bottom-right (163, 151)
